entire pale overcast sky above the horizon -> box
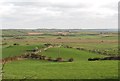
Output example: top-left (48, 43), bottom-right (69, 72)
top-left (0, 0), bottom-right (119, 29)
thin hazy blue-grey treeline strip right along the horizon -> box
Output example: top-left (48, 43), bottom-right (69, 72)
top-left (2, 29), bottom-right (118, 32)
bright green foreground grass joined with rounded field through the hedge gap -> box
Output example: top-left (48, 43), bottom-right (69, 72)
top-left (4, 48), bottom-right (118, 79)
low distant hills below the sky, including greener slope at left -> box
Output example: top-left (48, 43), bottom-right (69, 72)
top-left (2, 29), bottom-right (118, 35)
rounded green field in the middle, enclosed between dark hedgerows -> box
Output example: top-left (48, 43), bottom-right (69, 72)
top-left (43, 48), bottom-right (103, 61)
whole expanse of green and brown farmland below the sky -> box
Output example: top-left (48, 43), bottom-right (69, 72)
top-left (2, 30), bottom-right (119, 79)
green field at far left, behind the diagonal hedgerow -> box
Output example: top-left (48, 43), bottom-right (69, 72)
top-left (2, 44), bottom-right (43, 58)
